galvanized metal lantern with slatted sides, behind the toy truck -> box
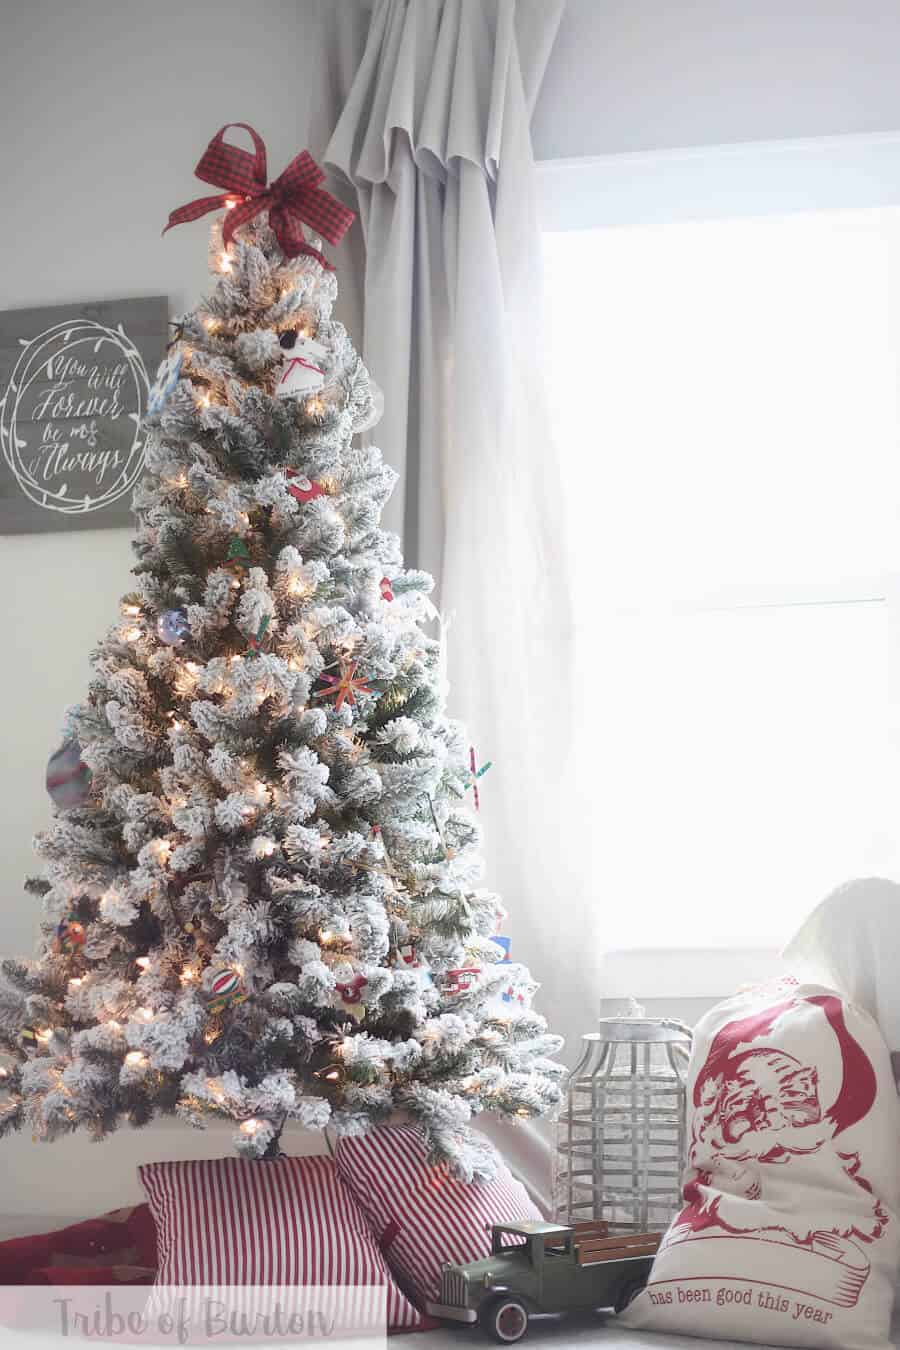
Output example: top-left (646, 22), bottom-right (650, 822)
top-left (555, 1008), bottom-right (691, 1233)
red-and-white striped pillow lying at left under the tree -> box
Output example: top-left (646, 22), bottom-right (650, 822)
top-left (138, 1157), bottom-right (429, 1331)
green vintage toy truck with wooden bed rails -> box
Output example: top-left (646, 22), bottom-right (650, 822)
top-left (428, 1222), bottom-right (661, 1345)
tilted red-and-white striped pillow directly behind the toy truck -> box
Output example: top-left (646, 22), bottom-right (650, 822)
top-left (335, 1125), bottom-right (542, 1308)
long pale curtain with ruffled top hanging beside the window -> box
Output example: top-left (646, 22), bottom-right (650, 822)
top-left (325, 0), bottom-right (585, 1200)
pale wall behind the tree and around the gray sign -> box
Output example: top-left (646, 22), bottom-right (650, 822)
top-left (0, 0), bottom-right (356, 1227)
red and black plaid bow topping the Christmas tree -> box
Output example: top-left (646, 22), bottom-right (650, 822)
top-left (163, 122), bottom-right (354, 271)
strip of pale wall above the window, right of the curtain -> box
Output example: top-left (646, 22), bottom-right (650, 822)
top-left (534, 0), bottom-right (900, 159)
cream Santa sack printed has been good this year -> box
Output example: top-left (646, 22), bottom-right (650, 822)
top-left (622, 984), bottom-right (900, 1350)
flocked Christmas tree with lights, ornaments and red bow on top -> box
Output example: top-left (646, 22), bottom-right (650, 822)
top-left (0, 128), bottom-right (561, 1176)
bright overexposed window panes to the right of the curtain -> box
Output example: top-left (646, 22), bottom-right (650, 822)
top-left (545, 208), bottom-right (900, 946)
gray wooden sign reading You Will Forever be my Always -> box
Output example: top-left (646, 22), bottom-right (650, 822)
top-left (0, 296), bottom-right (169, 535)
